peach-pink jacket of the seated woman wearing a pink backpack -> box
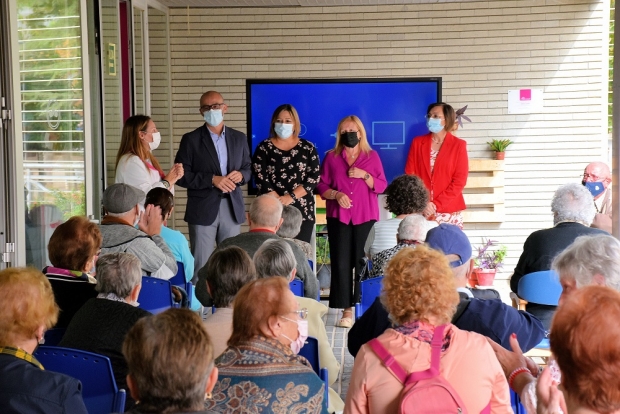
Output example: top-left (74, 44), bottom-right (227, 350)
top-left (344, 325), bottom-right (513, 414)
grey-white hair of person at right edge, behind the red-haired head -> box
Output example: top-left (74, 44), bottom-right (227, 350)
top-left (551, 234), bottom-right (620, 291)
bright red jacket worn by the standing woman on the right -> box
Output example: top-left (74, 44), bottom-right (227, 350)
top-left (405, 132), bottom-right (469, 213)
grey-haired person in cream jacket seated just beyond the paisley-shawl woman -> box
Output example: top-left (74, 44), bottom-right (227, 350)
top-left (254, 239), bottom-right (344, 412)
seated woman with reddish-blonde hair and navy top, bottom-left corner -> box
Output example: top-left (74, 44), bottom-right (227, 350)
top-left (0, 267), bottom-right (88, 414)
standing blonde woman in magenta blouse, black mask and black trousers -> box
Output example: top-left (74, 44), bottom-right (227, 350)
top-left (317, 115), bottom-right (387, 328)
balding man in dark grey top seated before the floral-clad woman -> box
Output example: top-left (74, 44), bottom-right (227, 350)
top-left (214, 195), bottom-right (318, 299)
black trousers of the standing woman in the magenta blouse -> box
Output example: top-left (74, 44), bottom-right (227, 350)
top-left (327, 218), bottom-right (375, 309)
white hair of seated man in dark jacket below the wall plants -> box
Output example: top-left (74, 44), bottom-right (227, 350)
top-left (551, 183), bottom-right (596, 226)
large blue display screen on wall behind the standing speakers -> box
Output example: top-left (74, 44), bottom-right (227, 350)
top-left (246, 78), bottom-right (441, 189)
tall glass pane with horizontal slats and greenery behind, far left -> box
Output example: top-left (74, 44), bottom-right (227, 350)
top-left (13, 0), bottom-right (92, 269)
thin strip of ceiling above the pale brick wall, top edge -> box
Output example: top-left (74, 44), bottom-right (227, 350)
top-left (159, 0), bottom-right (474, 7)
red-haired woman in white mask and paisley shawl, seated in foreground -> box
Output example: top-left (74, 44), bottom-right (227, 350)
top-left (206, 277), bottom-right (327, 413)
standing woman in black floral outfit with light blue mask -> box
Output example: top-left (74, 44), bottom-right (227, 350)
top-left (252, 104), bottom-right (320, 243)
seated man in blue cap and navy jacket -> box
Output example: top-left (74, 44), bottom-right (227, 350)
top-left (348, 223), bottom-right (545, 356)
